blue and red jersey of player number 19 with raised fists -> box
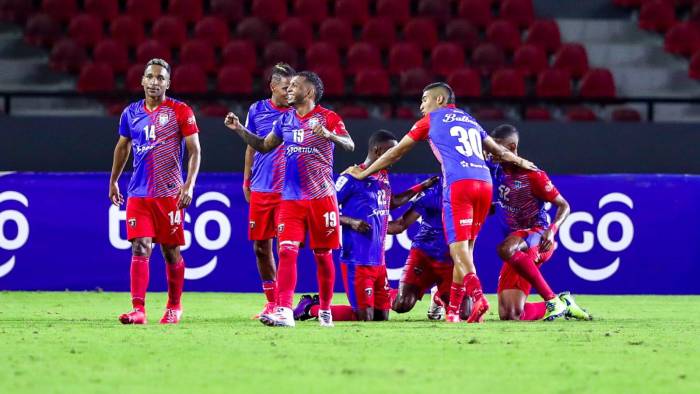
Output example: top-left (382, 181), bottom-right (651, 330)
top-left (272, 105), bottom-right (348, 200)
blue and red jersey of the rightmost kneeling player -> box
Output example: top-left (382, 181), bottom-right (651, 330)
top-left (492, 165), bottom-right (559, 233)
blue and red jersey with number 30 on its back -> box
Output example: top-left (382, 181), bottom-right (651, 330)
top-left (408, 105), bottom-right (491, 190)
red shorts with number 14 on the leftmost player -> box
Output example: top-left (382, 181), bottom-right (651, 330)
top-left (126, 197), bottom-right (185, 245)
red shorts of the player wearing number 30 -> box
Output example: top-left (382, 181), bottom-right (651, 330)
top-left (442, 179), bottom-right (492, 244)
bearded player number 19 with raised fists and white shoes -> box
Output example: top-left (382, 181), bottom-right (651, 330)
top-left (224, 71), bottom-right (355, 327)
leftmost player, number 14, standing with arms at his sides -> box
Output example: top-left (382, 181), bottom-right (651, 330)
top-left (109, 59), bottom-right (201, 324)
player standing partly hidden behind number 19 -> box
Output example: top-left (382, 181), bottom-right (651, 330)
top-left (243, 63), bottom-right (295, 319)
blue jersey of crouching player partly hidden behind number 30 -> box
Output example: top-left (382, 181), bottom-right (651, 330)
top-left (410, 183), bottom-right (452, 263)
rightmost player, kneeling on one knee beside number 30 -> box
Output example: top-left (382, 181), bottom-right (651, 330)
top-left (491, 124), bottom-right (590, 320)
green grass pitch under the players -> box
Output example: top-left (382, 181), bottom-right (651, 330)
top-left (0, 292), bottom-right (700, 394)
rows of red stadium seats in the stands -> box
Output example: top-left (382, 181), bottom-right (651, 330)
top-left (0, 0), bottom-right (624, 120)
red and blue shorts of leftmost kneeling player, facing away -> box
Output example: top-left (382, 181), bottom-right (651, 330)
top-left (340, 262), bottom-right (391, 311)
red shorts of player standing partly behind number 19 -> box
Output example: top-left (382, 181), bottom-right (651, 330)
top-left (248, 191), bottom-right (282, 241)
